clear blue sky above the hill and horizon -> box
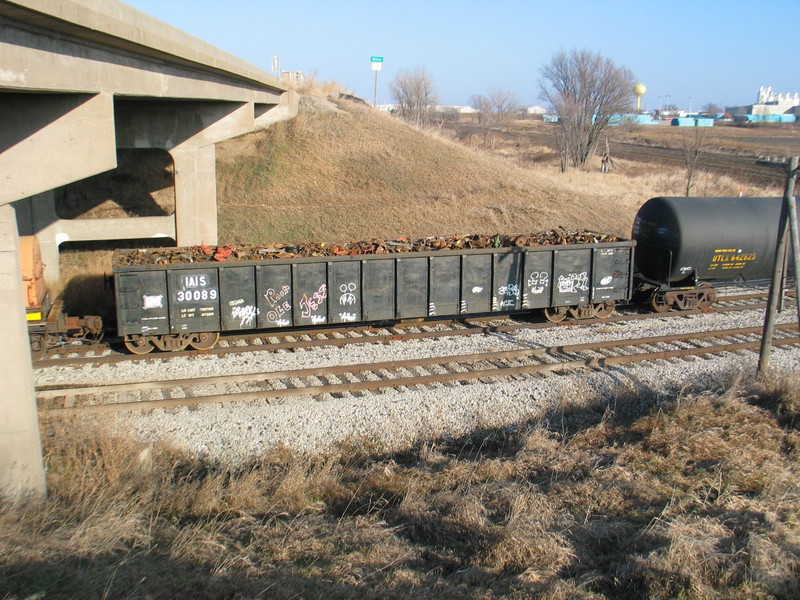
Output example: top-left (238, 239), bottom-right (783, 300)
top-left (127, 0), bottom-right (800, 110)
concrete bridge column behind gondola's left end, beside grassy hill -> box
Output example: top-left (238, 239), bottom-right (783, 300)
top-left (169, 145), bottom-right (217, 246)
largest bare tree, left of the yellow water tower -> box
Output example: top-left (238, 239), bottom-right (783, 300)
top-left (540, 50), bottom-right (635, 171)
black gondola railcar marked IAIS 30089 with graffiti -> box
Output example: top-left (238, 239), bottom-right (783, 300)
top-left (114, 241), bottom-right (635, 354)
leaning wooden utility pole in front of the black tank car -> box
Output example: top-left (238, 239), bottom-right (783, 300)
top-left (758, 156), bottom-right (800, 376)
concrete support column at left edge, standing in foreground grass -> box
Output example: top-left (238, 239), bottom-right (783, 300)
top-left (0, 205), bottom-right (45, 498)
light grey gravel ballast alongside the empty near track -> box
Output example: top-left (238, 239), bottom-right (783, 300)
top-left (35, 310), bottom-right (800, 464)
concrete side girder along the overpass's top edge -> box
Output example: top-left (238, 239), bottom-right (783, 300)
top-left (0, 8), bottom-right (286, 104)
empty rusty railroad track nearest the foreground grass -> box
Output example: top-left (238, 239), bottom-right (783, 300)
top-left (36, 324), bottom-right (800, 417)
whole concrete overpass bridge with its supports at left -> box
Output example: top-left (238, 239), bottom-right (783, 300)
top-left (0, 0), bottom-right (297, 495)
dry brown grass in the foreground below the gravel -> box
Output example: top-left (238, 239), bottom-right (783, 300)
top-left (0, 378), bottom-right (800, 600)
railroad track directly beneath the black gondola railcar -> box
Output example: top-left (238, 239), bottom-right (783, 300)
top-left (33, 292), bottom-right (788, 368)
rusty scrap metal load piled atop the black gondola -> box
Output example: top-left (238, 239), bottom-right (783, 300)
top-left (117, 229), bottom-right (619, 265)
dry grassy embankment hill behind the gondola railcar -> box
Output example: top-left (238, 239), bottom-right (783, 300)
top-left (217, 100), bottom-right (768, 243)
